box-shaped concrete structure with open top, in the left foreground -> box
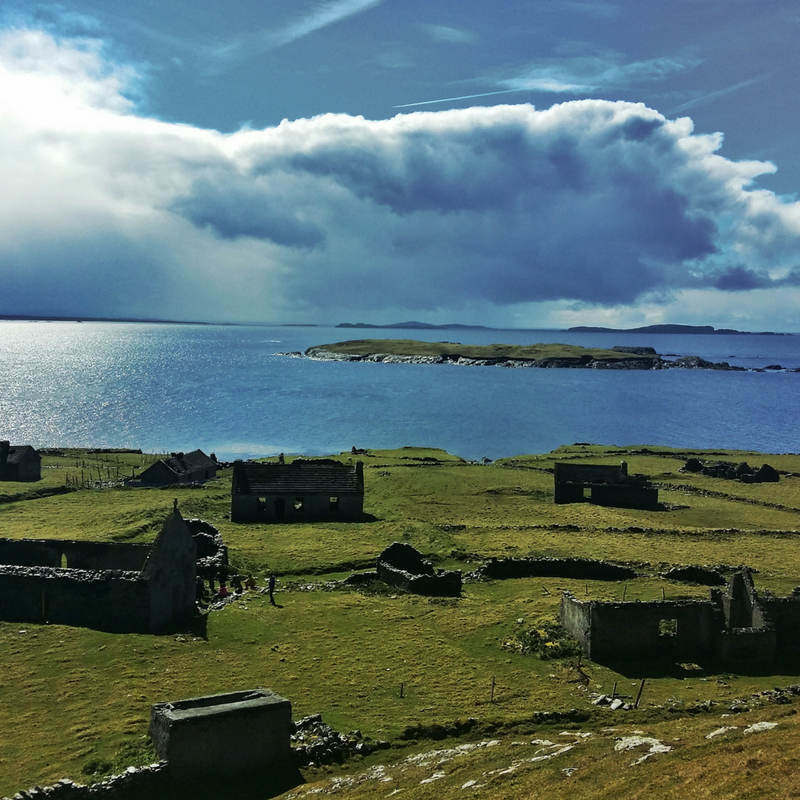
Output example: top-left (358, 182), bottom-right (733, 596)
top-left (150, 689), bottom-right (293, 778)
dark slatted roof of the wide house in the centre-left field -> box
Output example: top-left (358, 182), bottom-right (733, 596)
top-left (233, 460), bottom-right (364, 495)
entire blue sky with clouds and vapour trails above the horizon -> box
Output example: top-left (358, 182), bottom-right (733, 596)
top-left (0, 0), bottom-right (800, 332)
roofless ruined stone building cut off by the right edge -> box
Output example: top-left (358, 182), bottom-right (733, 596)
top-left (560, 568), bottom-right (800, 670)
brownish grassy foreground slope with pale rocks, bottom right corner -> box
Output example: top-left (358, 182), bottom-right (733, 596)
top-left (285, 706), bottom-right (800, 800)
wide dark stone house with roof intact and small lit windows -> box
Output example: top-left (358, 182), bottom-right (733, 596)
top-left (231, 459), bottom-right (364, 522)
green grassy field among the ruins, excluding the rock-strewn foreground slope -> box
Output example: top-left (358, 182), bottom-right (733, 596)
top-left (0, 447), bottom-right (800, 794)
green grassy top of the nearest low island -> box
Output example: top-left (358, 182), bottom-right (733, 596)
top-left (306, 339), bottom-right (655, 361)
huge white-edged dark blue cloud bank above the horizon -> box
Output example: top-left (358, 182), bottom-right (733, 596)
top-left (0, 31), bottom-right (800, 321)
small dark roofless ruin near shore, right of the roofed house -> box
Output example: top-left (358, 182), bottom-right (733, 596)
top-left (553, 461), bottom-right (658, 508)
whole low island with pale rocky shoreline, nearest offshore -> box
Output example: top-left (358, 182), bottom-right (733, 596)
top-left (276, 339), bottom-right (800, 372)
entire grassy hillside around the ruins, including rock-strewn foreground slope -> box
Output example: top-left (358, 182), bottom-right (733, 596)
top-left (0, 445), bottom-right (800, 797)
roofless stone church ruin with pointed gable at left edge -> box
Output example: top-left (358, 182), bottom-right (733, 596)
top-left (0, 506), bottom-right (197, 633)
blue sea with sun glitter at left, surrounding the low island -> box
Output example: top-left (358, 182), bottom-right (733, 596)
top-left (0, 321), bottom-right (800, 460)
